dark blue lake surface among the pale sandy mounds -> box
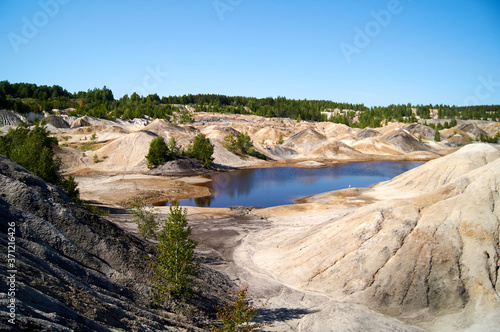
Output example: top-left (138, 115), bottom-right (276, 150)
top-left (179, 161), bottom-right (422, 207)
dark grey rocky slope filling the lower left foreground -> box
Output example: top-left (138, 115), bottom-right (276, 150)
top-left (0, 155), bottom-right (229, 331)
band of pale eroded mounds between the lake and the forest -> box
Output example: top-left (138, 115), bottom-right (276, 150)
top-left (35, 113), bottom-right (484, 173)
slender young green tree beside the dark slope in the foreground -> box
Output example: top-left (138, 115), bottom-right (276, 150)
top-left (153, 204), bottom-right (199, 301)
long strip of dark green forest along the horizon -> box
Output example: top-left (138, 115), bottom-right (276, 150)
top-left (0, 81), bottom-right (500, 128)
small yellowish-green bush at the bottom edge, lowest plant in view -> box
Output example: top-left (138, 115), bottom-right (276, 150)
top-left (212, 287), bottom-right (261, 332)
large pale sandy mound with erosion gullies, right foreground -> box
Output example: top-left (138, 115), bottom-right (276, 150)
top-left (253, 144), bottom-right (500, 331)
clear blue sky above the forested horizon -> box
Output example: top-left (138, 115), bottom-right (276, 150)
top-left (0, 0), bottom-right (500, 106)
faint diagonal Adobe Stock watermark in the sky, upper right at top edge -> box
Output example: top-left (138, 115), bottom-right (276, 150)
top-left (339, 0), bottom-right (411, 63)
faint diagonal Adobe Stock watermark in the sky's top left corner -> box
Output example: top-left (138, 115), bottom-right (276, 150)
top-left (7, 0), bottom-right (70, 54)
